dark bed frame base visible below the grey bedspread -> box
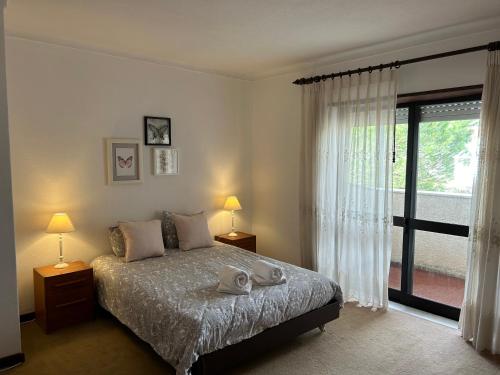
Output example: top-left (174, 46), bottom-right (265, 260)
top-left (191, 299), bottom-right (340, 375)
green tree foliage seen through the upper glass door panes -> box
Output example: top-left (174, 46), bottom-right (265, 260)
top-left (393, 120), bottom-right (477, 192)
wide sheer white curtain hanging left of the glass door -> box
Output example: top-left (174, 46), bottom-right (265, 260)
top-left (300, 70), bottom-right (397, 308)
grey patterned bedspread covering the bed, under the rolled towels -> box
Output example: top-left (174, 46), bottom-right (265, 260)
top-left (92, 243), bottom-right (342, 374)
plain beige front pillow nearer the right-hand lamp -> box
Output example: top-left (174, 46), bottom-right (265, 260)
top-left (173, 212), bottom-right (214, 250)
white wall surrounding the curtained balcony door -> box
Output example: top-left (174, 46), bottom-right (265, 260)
top-left (251, 30), bottom-right (500, 264)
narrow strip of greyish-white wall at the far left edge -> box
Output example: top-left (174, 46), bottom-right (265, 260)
top-left (0, 1), bottom-right (21, 358)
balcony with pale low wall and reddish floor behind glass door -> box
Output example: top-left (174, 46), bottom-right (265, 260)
top-left (389, 190), bottom-right (471, 307)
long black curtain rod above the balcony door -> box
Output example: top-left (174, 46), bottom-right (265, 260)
top-left (293, 41), bottom-right (500, 85)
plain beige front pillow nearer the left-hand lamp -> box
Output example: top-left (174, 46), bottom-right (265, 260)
top-left (118, 220), bottom-right (165, 262)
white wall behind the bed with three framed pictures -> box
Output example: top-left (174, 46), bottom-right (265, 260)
top-left (2, 37), bottom-right (252, 313)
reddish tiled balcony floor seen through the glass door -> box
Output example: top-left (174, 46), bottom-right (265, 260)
top-left (389, 263), bottom-right (465, 307)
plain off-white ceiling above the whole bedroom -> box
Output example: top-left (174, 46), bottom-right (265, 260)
top-left (6, 0), bottom-right (500, 79)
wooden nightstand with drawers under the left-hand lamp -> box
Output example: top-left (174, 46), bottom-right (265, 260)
top-left (33, 261), bottom-right (94, 333)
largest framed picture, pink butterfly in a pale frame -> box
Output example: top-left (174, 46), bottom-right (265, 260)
top-left (106, 138), bottom-right (142, 184)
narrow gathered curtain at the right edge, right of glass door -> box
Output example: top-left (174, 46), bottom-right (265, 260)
top-left (460, 51), bottom-right (500, 354)
